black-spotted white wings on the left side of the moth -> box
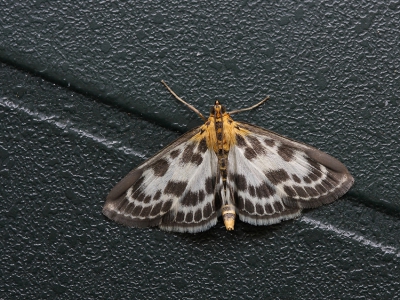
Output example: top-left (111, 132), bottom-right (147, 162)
top-left (103, 128), bottom-right (220, 232)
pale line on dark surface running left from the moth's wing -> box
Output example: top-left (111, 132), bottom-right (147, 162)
top-left (0, 98), bottom-right (146, 159)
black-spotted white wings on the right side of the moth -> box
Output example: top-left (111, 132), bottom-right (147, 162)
top-left (228, 122), bottom-right (354, 225)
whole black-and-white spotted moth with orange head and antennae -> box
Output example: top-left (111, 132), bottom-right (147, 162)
top-left (103, 81), bottom-right (354, 233)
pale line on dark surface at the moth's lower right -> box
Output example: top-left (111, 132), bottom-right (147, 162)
top-left (299, 216), bottom-right (400, 257)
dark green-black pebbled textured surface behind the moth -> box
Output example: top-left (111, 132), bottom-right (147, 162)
top-left (0, 1), bottom-right (400, 299)
